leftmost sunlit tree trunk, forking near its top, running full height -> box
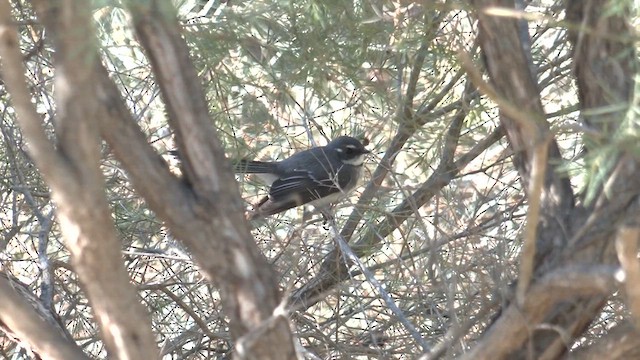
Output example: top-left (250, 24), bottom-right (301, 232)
top-left (5, 1), bottom-right (157, 359)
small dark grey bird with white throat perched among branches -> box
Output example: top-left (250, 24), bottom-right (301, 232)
top-left (234, 136), bottom-right (369, 220)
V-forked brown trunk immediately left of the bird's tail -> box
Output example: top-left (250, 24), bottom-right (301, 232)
top-left (89, 1), bottom-right (294, 359)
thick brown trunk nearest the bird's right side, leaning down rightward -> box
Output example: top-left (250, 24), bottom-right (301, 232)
top-left (472, 0), bottom-right (574, 262)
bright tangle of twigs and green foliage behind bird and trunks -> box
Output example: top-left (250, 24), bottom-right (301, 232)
top-left (0, 0), bottom-right (624, 359)
